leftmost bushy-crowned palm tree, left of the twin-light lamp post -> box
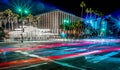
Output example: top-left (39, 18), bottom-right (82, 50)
top-left (1, 9), bottom-right (19, 39)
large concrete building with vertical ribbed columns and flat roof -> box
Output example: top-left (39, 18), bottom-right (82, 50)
top-left (37, 9), bottom-right (82, 34)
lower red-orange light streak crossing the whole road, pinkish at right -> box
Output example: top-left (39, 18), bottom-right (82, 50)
top-left (0, 47), bottom-right (120, 67)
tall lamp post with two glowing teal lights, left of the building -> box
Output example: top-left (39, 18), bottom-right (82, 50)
top-left (18, 8), bottom-right (29, 43)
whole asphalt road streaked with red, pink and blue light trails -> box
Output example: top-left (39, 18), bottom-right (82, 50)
top-left (0, 39), bottom-right (120, 70)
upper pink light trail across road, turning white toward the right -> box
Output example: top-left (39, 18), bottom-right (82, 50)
top-left (0, 39), bottom-right (120, 53)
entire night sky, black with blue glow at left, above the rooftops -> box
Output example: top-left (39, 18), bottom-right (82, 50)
top-left (0, 0), bottom-right (120, 16)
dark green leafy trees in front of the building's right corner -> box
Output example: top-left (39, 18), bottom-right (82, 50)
top-left (61, 21), bottom-right (84, 38)
